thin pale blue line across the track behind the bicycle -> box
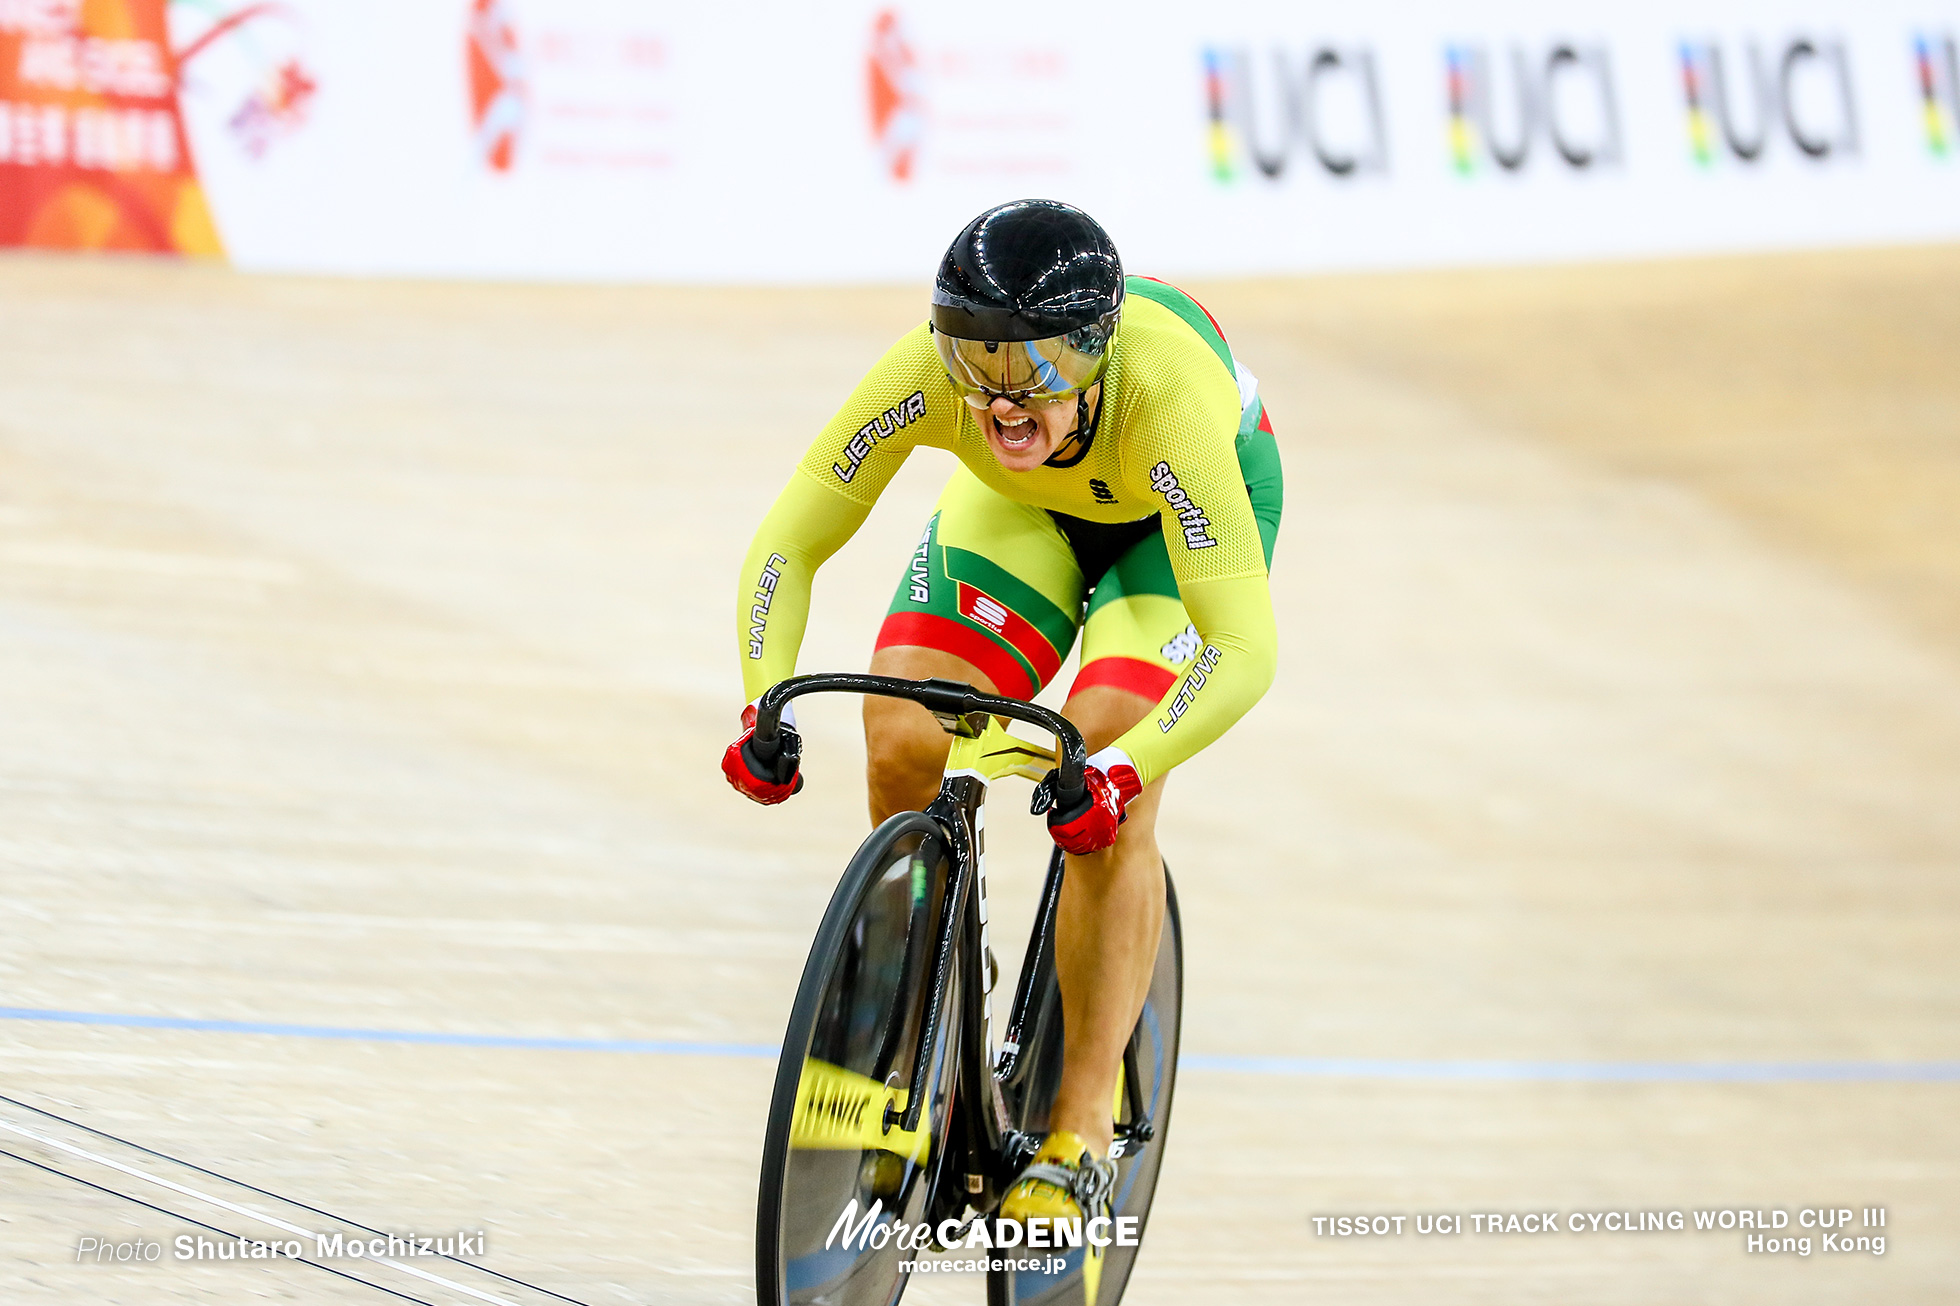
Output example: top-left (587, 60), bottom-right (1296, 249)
top-left (0, 1006), bottom-right (1960, 1084)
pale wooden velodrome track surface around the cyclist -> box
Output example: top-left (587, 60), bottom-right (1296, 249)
top-left (0, 249), bottom-right (1960, 1306)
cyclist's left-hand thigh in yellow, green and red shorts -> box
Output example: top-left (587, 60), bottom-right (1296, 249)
top-left (878, 467), bottom-right (1082, 698)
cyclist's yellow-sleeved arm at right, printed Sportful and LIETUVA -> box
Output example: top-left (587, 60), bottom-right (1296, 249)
top-left (1115, 386), bottom-right (1280, 784)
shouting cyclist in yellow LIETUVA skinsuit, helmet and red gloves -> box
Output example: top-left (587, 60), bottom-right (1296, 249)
top-left (723, 200), bottom-right (1282, 1239)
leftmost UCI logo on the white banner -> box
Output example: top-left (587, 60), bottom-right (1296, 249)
top-left (1205, 45), bottom-right (1388, 182)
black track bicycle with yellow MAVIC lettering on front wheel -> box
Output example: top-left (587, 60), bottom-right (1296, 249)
top-left (755, 675), bottom-right (1184, 1306)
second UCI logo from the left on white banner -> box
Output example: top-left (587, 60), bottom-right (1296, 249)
top-left (1443, 43), bottom-right (1623, 176)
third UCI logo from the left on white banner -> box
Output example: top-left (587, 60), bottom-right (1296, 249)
top-left (1680, 35), bottom-right (1858, 167)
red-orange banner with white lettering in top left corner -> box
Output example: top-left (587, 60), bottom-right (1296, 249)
top-left (0, 0), bottom-right (223, 257)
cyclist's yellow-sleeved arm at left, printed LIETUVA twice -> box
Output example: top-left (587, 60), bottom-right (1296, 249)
top-left (735, 324), bottom-right (958, 702)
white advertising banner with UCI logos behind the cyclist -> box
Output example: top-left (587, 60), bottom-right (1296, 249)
top-left (103, 0), bottom-right (1960, 280)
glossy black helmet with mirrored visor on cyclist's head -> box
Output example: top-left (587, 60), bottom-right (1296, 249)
top-left (931, 200), bottom-right (1123, 408)
